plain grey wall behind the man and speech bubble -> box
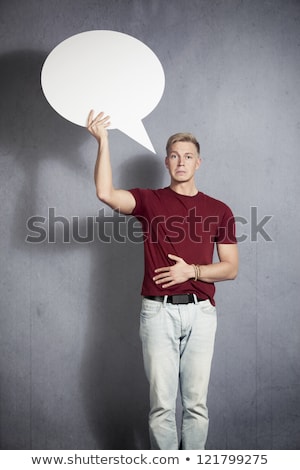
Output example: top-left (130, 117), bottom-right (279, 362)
top-left (0, 0), bottom-right (300, 449)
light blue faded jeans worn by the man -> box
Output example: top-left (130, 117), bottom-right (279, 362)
top-left (140, 297), bottom-right (217, 450)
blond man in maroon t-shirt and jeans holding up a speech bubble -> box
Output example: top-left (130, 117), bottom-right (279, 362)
top-left (88, 111), bottom-right (238, 449)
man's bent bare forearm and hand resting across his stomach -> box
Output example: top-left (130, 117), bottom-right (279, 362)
top-left (153, 244), bottom-right (238, 288)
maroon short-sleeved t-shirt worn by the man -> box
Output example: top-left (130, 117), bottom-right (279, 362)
top-left (130, 188), bottom-right (236, 304)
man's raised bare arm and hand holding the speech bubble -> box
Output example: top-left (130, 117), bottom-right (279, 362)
top-left (88, 111), bottom-right (136, 214)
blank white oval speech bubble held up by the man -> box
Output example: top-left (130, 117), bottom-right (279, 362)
top-left (41, 30), bottom-right (165, 153)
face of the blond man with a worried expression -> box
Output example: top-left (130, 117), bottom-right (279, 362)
top-left (165, 142), bottom-right (201, 183)
